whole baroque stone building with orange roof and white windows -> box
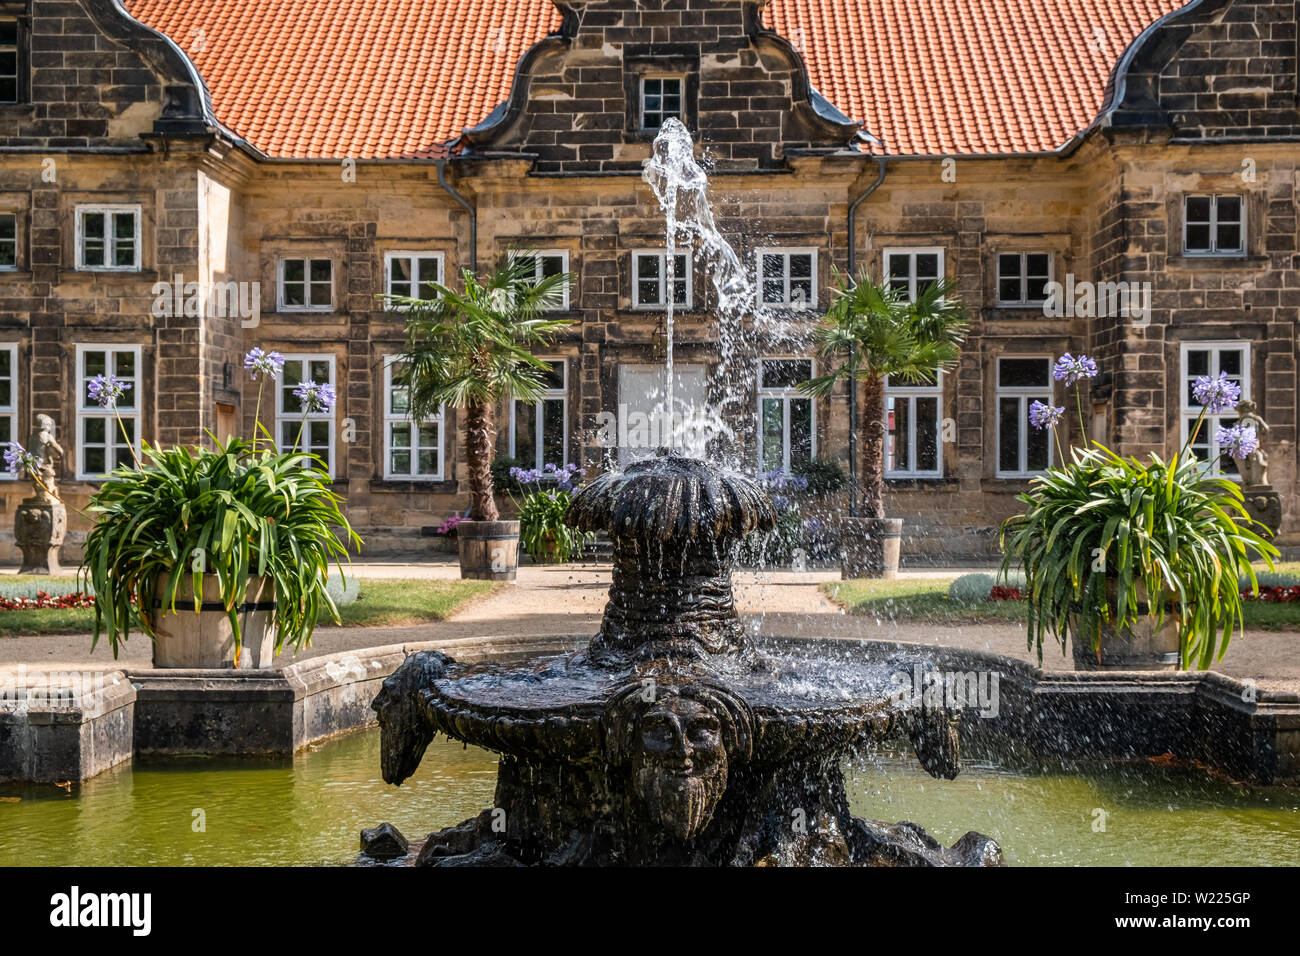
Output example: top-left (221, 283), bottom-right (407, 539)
top-left (0, 0), bottom-right (1300, 561)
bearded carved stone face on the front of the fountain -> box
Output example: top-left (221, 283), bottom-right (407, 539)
top-left (632, 697), bottom-right (727, 839)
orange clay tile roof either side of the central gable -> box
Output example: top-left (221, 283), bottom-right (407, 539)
top-left (126, 0), bottom-right (1186, 159)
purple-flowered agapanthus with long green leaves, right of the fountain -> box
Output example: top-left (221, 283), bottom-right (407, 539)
top-left (1001, 354), bottom-right (1278, 669)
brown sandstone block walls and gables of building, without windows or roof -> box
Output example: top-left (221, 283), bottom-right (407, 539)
top-left (0, 0), bottom-right (1300, 562)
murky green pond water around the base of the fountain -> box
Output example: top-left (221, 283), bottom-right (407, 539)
top-left (0, 731), bottom-right (1300, 866)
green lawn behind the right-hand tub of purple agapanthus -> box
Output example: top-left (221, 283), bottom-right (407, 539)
top-left (822, 562), bottom-right (1300, 631)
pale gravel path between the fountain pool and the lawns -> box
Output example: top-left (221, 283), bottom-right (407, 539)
top-left (0, 561), bottom-right (1300, 691)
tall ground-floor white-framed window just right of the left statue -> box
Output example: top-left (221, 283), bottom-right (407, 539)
top-left (77, 345), bottom-right (142, 481)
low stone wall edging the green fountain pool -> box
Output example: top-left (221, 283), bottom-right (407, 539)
top-left (0, 633), bottom-right (1300, 783)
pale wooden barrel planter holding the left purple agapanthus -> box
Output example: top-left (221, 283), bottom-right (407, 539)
top-left (153, 575), bottom-right (276, 670)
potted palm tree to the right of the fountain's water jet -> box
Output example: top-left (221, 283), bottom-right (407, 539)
top-left (800, 272), bottom-right (967, 579)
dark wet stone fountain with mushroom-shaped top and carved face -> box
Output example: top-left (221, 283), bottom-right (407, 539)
top-left (373, 453), bottom-right (1001, 866)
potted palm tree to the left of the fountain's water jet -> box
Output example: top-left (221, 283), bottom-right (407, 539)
top-left (386, 251), bottom-right (572, 581)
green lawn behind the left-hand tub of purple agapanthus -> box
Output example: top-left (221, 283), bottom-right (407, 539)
top-left (0, 576), bottom-right (497, 637)
